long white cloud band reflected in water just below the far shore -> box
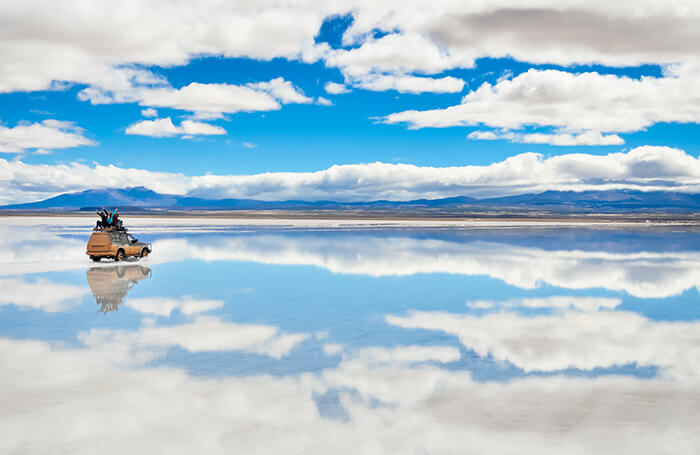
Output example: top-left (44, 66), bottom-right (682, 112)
top-left (5, 220), bottom-right (700, 298)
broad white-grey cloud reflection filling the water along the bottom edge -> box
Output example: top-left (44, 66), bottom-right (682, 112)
top-left (5, 334), bottom-right (700, 455)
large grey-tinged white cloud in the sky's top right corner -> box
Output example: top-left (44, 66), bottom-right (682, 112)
top-left (344, 0), bottom-right (700, 67)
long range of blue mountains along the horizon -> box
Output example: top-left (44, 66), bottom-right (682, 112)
top-left (0, 187), bottom-right (700, 213)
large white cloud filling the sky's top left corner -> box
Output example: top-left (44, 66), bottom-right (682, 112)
top-left (0, 0), bottom-right (332, 92)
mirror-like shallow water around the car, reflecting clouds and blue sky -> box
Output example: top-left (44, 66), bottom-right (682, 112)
top-left (0, 218), bottom-right (700, 454)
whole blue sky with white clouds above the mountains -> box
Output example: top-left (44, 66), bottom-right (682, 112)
top-left (0, 0), bottom-right (700, 204)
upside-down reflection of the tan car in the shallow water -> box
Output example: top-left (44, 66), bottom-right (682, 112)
top-left (85, 265), bottom-right (151, 314)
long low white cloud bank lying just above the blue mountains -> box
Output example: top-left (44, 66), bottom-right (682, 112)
top-left (0, 146), bottom-right (700, 203)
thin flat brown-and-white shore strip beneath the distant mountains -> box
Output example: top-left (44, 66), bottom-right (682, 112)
top-left (0, 210), bottom-right (700, 225)
